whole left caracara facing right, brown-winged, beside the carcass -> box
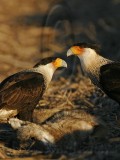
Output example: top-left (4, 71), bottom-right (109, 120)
top-left (0, 57), bottom-right (67, 121)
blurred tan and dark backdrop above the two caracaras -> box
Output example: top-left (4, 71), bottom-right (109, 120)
top-left (0, 0), bottom-right (120, 81)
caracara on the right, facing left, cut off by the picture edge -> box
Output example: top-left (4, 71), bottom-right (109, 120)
top-left (67, 43), bottom-right (120, 104)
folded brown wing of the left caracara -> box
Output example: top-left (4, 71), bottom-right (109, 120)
top-left (0, 72), bottom-right (45, 109)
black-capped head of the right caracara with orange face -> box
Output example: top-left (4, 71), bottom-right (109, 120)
top-left (67, 42), bottom-right (100, 58)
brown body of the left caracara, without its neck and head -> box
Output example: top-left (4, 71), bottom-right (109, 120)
top-left (0, 71), bottom-right (46, 119)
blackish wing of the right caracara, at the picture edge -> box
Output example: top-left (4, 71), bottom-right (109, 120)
top-left (100, 63), bottom-right (120, 103)
